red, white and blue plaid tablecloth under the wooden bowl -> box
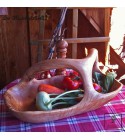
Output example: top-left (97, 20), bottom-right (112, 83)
top-left (0, 79), bottom-right (125, 132)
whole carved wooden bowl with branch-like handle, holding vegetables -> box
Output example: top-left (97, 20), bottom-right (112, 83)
top-left (4, 48), bottom-right (122, 123)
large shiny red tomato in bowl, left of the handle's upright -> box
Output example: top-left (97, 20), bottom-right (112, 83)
top-left (63, 76), bottom-right (79, 90)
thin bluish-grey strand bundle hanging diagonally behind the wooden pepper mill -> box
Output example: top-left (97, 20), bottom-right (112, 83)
top-left (48, 7), bottom-right (67, 59)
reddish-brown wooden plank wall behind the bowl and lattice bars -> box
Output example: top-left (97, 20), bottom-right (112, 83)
top-left (0, 7), bottom-right (111, 88)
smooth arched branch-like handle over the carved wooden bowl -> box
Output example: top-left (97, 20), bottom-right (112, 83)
top-left (22, 49), bottom-right (98, 95)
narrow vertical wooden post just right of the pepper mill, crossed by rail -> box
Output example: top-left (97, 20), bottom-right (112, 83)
top-left (72, 9), bottom-right (78, 58)
